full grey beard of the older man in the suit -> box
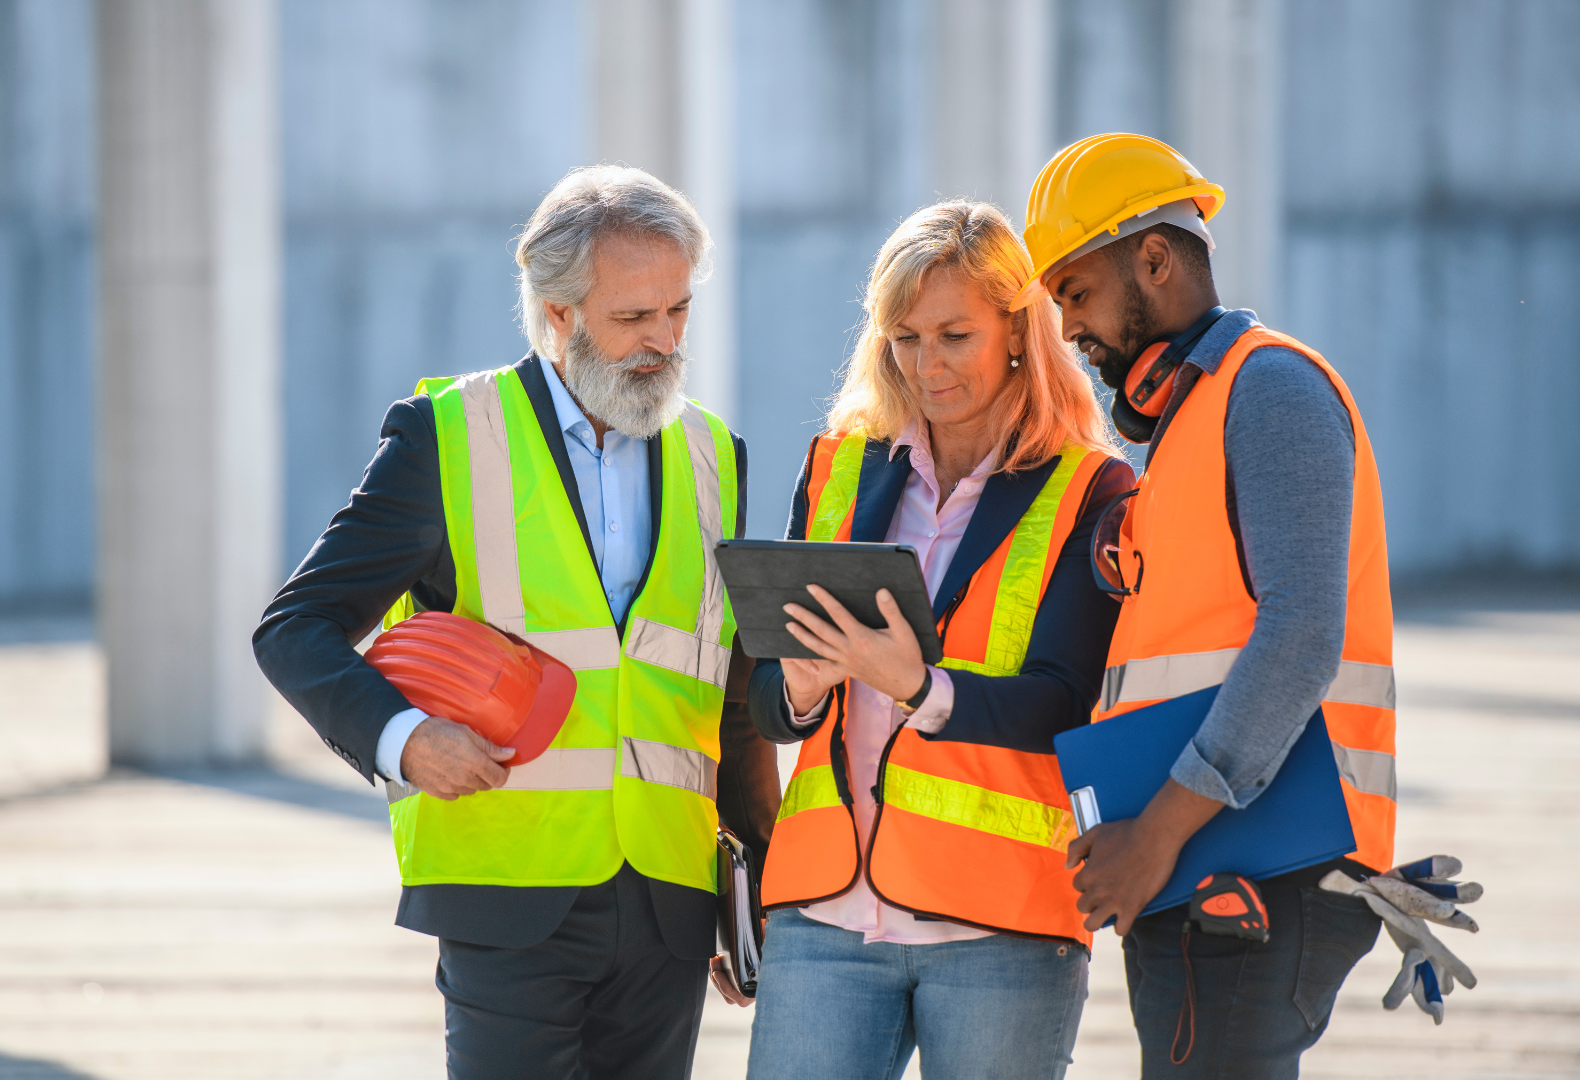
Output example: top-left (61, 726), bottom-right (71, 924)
top-left (564, 317), bottom-right (690, 439)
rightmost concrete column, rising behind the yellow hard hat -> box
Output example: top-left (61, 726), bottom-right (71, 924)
top-left (1171, 0), bottom-right (1285, 325)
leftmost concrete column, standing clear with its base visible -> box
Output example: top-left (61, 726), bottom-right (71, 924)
top-left (98, 0), bottom-right (280, 767)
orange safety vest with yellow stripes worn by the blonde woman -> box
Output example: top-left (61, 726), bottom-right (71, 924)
top-left (762, 434), bottom-right (1108, 946)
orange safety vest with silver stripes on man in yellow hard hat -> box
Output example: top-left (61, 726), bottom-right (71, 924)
top-left (1093, 325), bottom-right (1397, 870)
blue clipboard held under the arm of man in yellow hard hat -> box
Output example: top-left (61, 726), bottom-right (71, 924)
top-left (1054, 687), bottom-right (1356, 914)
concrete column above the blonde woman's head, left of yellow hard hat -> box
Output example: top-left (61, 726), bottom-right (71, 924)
top-left (924, 0), bottom-right (1057, 217)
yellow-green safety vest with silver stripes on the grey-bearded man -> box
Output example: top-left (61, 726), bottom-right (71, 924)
top-left (387, 368), bottom-right (736, 889)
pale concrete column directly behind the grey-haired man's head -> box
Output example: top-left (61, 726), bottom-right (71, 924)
top-left (588, 0), bottom-right (738, 422)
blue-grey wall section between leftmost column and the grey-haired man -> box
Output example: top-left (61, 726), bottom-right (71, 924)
top-left (281, 0), bottom-right (586, 565)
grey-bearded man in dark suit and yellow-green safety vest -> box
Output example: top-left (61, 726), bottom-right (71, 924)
top-left (254, 166), bottom-right (779, 1080)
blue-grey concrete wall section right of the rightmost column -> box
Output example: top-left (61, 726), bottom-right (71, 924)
top-left (1285, 0), bottom-right (1580, 572)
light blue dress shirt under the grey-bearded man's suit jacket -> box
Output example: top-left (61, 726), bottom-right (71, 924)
top-left (373, 362), bottom-right (653, 783)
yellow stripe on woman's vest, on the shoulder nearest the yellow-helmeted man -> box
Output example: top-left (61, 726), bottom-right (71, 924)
top-left (978, 442), bottom-right (1090, 676)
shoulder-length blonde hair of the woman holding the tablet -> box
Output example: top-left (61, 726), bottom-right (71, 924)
top-left (828, 201), bottom-right (1117, 472)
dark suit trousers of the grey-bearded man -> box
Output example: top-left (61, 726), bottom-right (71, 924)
top-left (438, 864), bottom-right (708, 1080)
